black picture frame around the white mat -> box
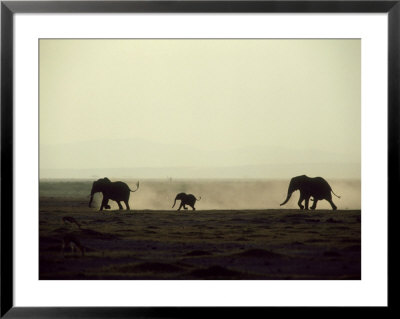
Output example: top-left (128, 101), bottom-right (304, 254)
top-left (0, 0), bottom-right (394, 318)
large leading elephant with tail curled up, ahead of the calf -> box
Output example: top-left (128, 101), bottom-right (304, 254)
top-left (89, 177), bottom-right (139, 210)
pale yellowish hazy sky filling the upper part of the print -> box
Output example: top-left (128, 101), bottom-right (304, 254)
top-left (40, 39), bottom-right (361, 179)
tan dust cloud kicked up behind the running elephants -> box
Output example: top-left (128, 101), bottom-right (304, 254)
top-left (87, 179), bottom-right (361, 210)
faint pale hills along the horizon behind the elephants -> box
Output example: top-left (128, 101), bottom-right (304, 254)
top-left (40, 139), bottom-right (361, 178)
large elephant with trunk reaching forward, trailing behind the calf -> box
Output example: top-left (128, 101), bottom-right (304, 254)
top-left (280, 175), bottom-right (340, 210)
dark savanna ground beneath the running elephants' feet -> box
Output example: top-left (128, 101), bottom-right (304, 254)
top-left (39, 181), bottom-right (361, 280)
